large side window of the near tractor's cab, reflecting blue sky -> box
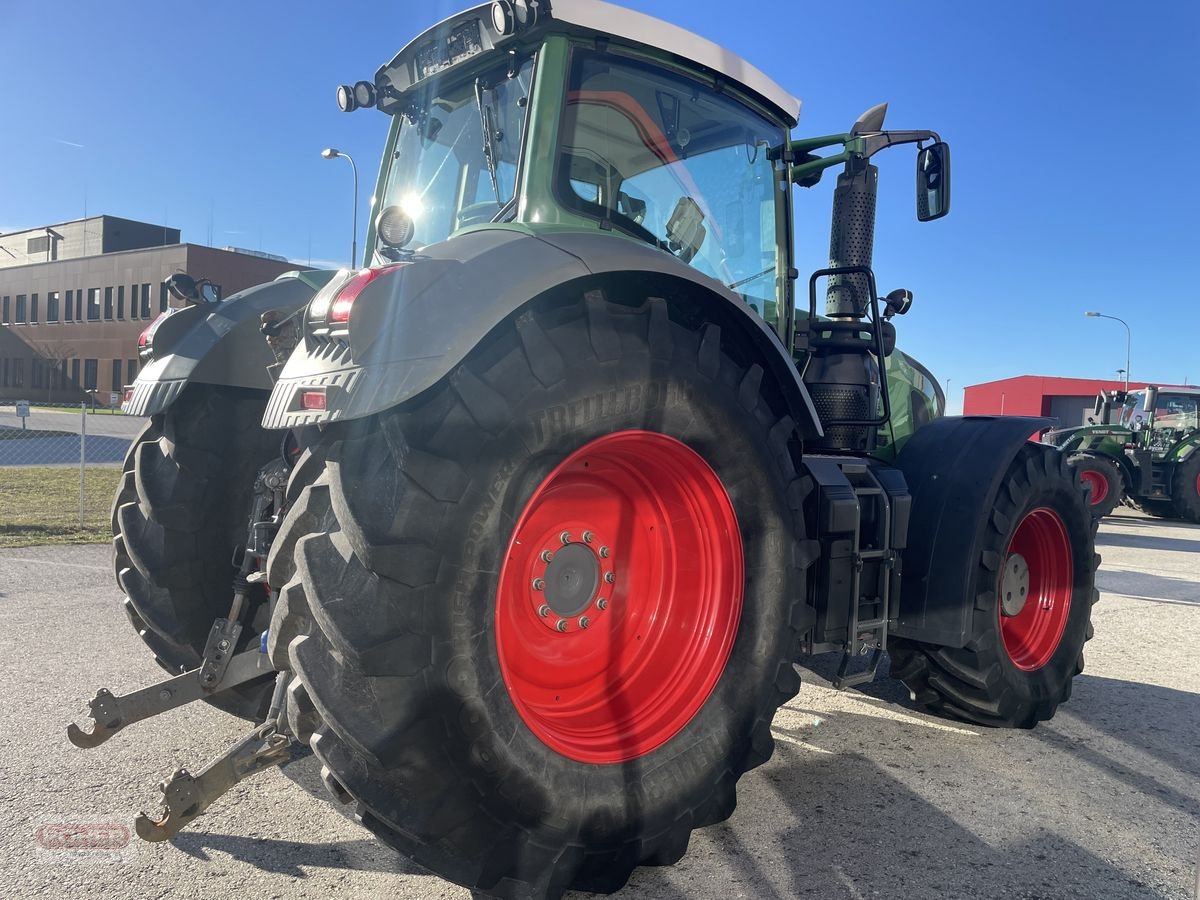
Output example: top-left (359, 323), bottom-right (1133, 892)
top-left (557, 50), bottom-right (786, 325)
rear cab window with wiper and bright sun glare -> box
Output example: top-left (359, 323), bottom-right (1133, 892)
top-left (380, 60), bottom-right (533, 248)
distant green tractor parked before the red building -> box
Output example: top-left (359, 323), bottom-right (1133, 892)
top-left (1042, 385), bottom-right (1200, 522)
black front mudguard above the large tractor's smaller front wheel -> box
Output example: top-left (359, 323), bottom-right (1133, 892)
top-left (892, 416), bottom-right (1055, 647)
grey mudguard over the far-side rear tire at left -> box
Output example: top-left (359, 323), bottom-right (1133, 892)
top-left (121, 271), bottom-right (334, 415)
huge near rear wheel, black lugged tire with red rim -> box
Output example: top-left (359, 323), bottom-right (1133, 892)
top-left (271, 293), bottom-right (811, 898)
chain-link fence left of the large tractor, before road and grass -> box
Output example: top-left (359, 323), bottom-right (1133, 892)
top-left (0, 401), bottom-right (145, 547)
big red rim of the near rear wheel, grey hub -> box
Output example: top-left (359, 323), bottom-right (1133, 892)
top-left (496, 431), bottom-right (744, 763)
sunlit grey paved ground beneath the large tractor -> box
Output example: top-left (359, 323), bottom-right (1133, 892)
top-left (0, 514), bottom-right (1200, 900)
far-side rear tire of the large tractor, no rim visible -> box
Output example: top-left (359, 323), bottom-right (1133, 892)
top-left (112, 384), bottom-right (280, 720)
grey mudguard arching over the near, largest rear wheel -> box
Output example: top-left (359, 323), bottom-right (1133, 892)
top-left (263, 228), bottom-right (822, 437)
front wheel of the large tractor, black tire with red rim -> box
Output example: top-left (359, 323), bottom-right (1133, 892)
top-left (888, 444), bottom-right (1099, 728)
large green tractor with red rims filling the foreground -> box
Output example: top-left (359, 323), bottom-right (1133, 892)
top-left (70, 0), bottom-right (1098, 899)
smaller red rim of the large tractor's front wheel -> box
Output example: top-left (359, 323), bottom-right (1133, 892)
top-left (997, 506), bottom-right (1074, 672)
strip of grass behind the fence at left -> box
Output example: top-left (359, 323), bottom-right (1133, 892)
top-left (0, 466), bottom-right (121, 547)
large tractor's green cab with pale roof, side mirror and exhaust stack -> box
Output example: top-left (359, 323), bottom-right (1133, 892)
top-left (338, 0), bottom-right (949, 432)
